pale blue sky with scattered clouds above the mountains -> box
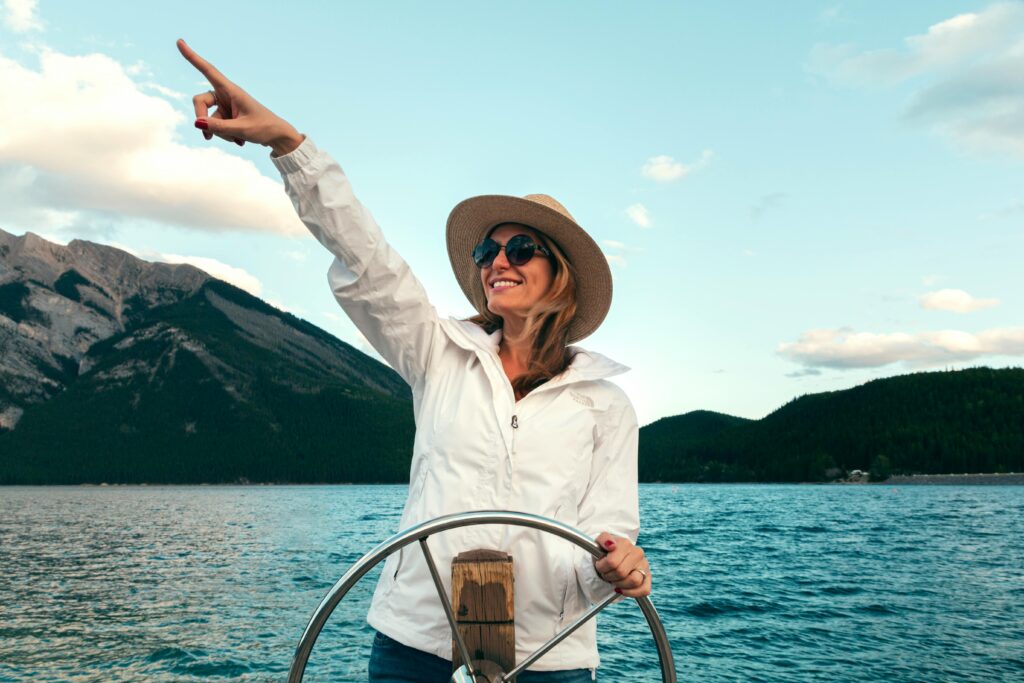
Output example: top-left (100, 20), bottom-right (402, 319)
top-left (0, 0), bottom-right (1024, 424)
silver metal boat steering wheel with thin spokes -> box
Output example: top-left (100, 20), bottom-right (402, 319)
top-left (288, 510), bottom-right (676, 683)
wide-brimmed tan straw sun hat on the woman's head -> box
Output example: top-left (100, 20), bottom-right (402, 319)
top-left (446, 195), bottom-right (611, 344)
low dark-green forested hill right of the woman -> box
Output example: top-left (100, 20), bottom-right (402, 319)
top-left (640, 368), bottom-right (1024, 481)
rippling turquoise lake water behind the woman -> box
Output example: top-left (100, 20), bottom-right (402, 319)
top-left (0, 484), bottom-right (1024, 681)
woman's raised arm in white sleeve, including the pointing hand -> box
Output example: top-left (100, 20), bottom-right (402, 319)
top-left (177, 40), bottom-right (441, 386)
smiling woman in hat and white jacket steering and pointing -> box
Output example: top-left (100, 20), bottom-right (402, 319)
top-left (178, 41), bottom-right (651, 683)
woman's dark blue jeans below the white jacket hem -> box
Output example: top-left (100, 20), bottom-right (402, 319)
top-left (370, 631), bottom-right (597, 683)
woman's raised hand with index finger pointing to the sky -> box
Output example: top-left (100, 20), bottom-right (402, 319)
top-left (178, 40), bottom-right (304, 157)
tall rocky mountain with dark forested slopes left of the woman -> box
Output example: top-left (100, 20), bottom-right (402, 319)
top-left (0, 230), bottom-right (414, 483)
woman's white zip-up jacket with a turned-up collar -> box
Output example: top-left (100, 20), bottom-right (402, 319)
top-left (271, 138), bottom-right (640, 671)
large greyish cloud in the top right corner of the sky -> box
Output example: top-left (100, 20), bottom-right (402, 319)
top-left (808, 2), bottom-right (1024, 156)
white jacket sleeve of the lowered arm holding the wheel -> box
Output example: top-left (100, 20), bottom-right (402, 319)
top-left (575, 394), bottom-right (640, 602)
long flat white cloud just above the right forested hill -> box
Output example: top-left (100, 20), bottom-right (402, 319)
top-left (776, 327), bottom-right (1024, 370)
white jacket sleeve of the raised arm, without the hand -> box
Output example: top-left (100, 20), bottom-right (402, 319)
top-left (270, 137), bottom-right (440, 386)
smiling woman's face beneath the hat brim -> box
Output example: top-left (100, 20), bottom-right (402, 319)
top-left (480, 223), bottom-right (554, 322)
